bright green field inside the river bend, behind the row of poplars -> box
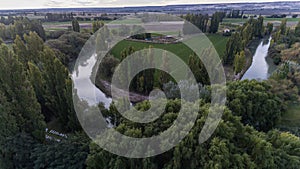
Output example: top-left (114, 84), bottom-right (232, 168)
top-left (111, 34), bottom-right (228, 62)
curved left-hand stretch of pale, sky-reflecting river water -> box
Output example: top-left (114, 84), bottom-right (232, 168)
top-left (72, 55), bottom-right (112, 108)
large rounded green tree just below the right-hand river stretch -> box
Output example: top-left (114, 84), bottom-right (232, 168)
top-left (227, 80), bottom-right (284, 131)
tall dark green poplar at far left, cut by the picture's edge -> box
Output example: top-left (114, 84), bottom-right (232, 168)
top-left (0, 45), bottom-right (46, 141)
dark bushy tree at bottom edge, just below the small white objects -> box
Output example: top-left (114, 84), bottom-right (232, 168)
top-left (30, 133), bottom-right (90, 169)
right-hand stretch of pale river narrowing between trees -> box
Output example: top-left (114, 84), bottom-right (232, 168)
top-left (242, 38), bottom-right (276, 80)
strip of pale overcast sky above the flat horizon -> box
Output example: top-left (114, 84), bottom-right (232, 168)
top-left (0, 0), bottom-right (299, 9)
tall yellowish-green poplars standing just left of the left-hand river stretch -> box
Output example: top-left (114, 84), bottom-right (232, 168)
top-left (14, 32), bottom-right (80, 131)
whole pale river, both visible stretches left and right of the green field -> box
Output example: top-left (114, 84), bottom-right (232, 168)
top-left (72, 38), bottom-right (276, 108)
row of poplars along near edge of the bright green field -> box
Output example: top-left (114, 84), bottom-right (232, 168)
top-left (96, 43), bottom-right (212, 94)
